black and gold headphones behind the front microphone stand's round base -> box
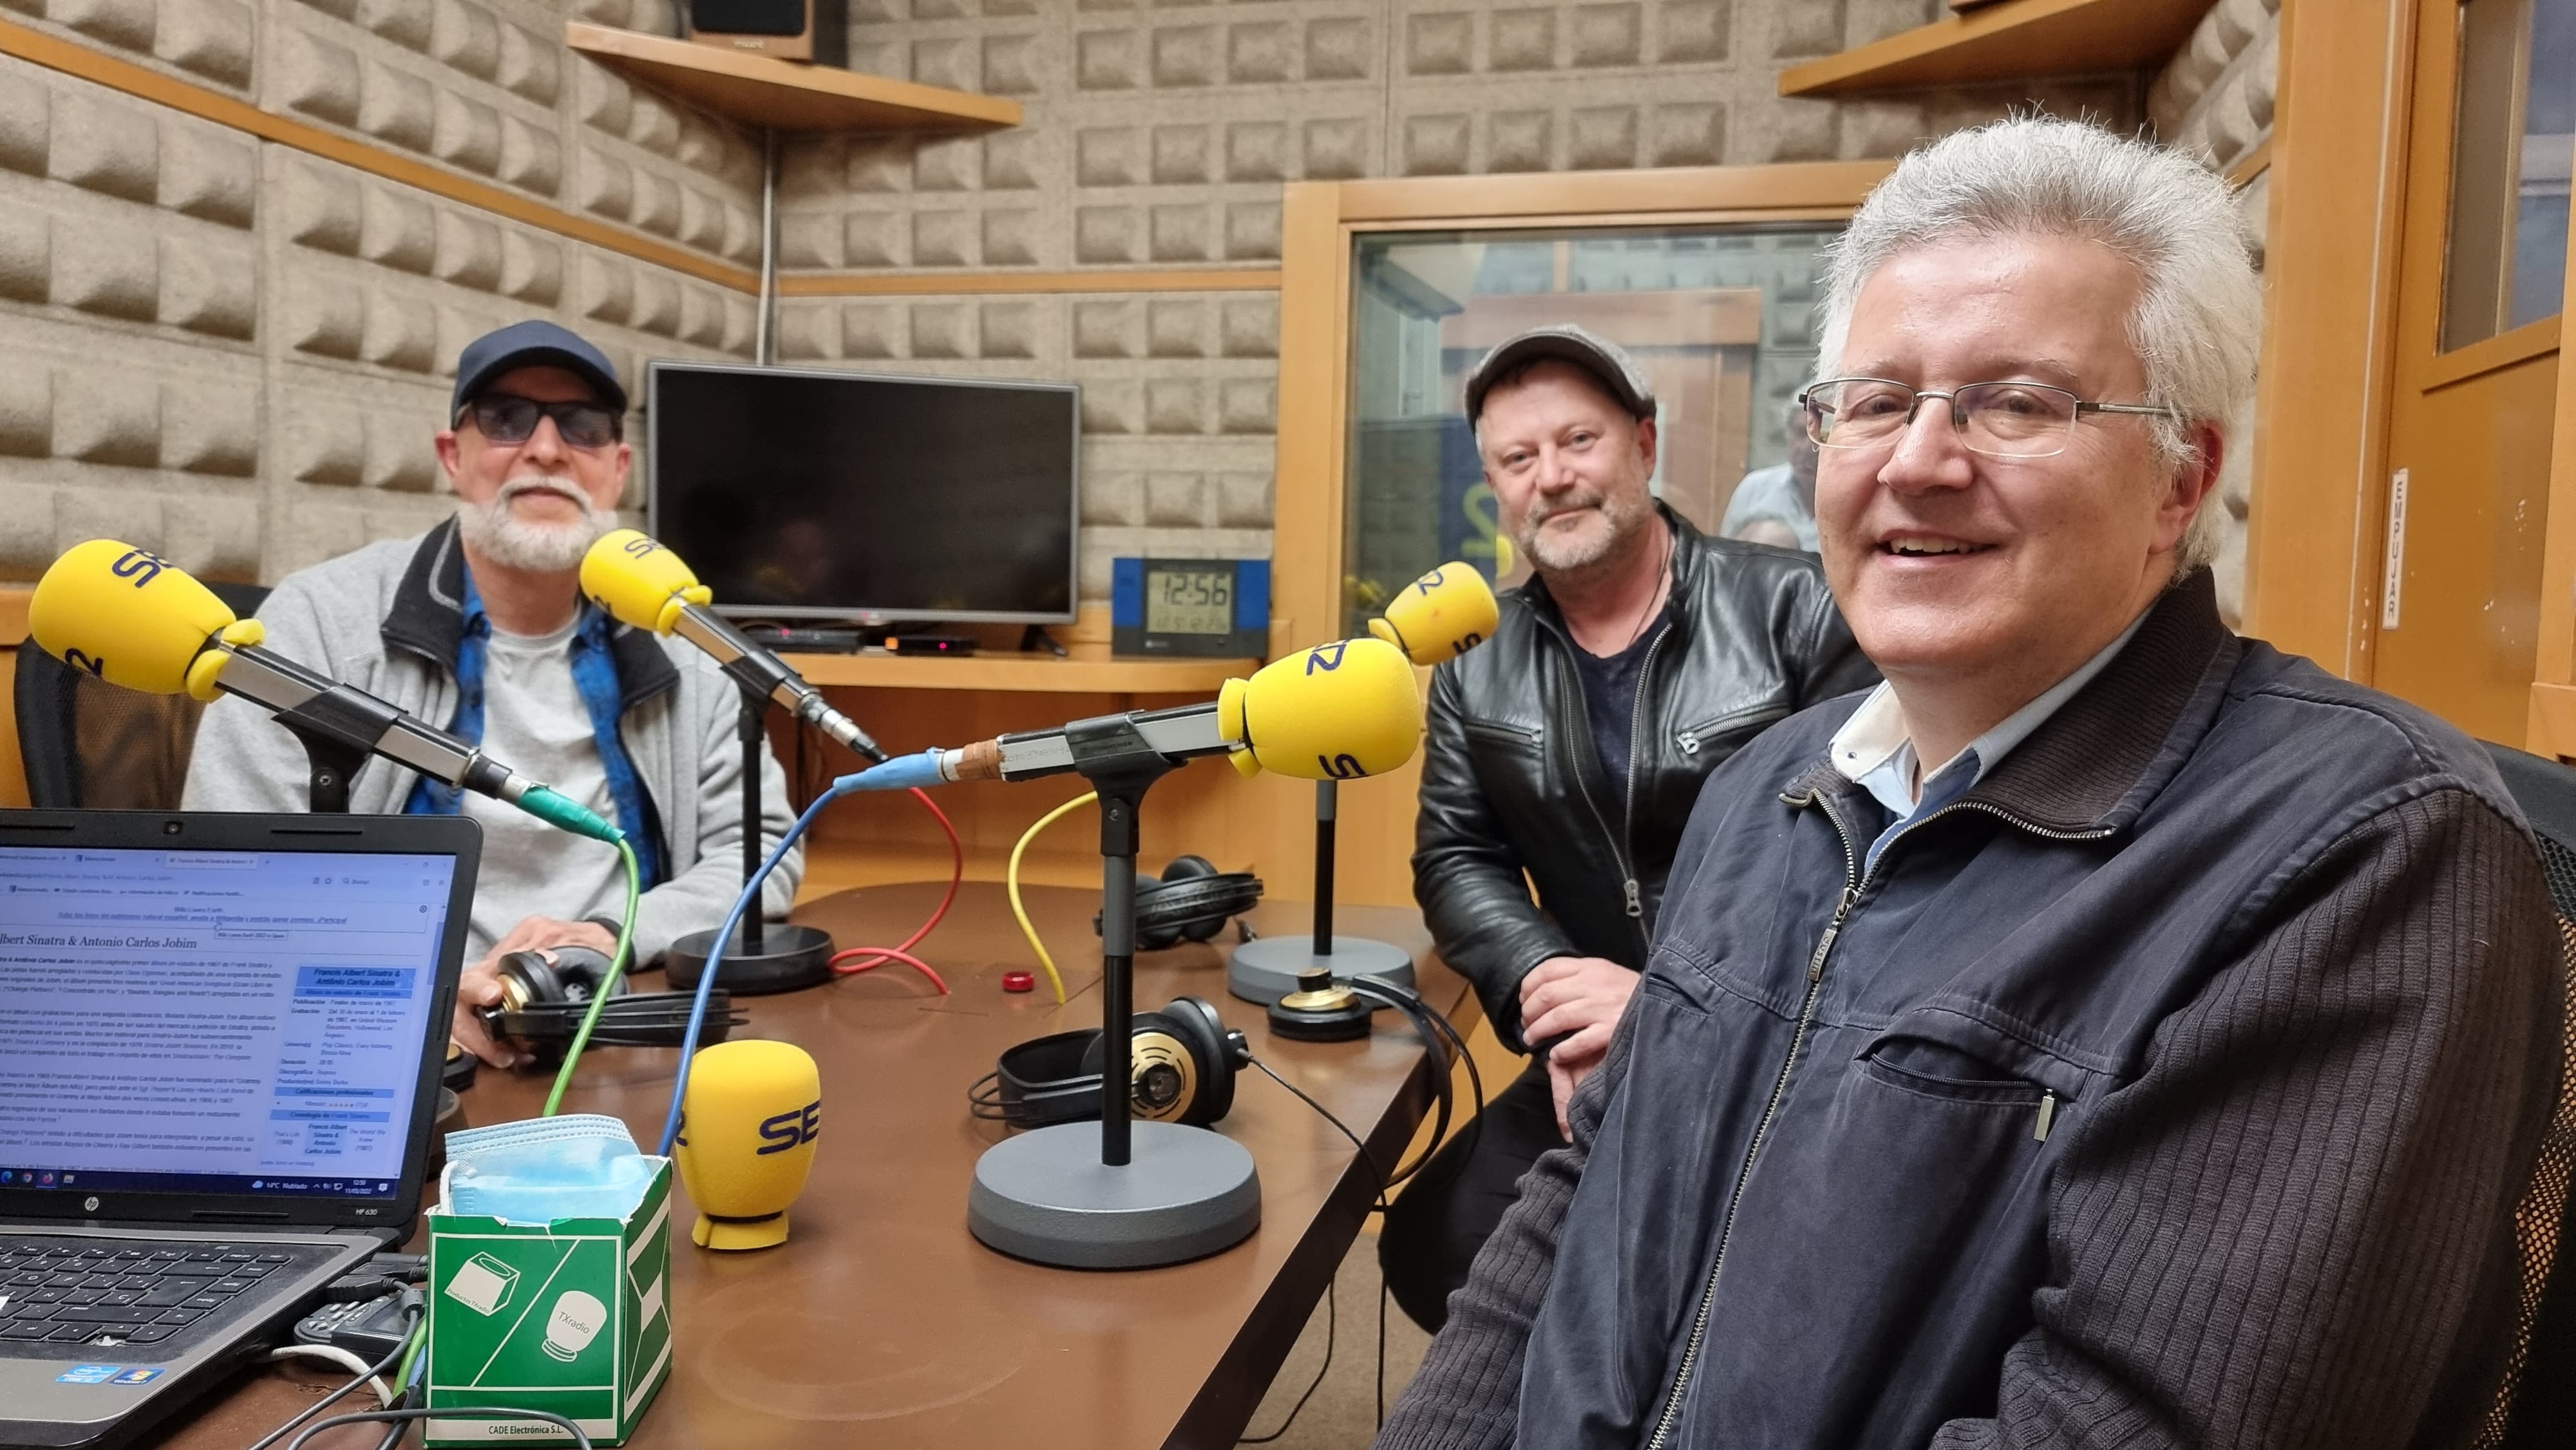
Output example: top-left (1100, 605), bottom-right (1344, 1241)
top-left (966, 997), bottom-right (1252, 1128)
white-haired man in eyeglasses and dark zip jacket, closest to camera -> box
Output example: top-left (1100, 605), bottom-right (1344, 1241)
top-left (1378, 118), bottom-right (2563, 1450)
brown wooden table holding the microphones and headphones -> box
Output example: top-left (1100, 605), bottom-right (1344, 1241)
top-left (151, 883), bottom-right (1468, 1450)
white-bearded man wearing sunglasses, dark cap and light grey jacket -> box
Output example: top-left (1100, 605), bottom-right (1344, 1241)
top-left (185, 322), bottom-right (801, 1066)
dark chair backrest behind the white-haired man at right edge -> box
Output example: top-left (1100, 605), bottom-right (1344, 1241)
top-left (2478, 744), bottom-right (2576, 1450)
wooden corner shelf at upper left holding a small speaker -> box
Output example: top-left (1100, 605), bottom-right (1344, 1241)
top-left (564, 21), bottom-right (1020, 131)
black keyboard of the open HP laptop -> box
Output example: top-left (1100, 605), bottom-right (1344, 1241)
top-left (0, 1234), bottom-right (314, 1347)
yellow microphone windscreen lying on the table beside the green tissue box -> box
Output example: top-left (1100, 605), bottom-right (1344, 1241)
top-left (672, 1038), bottom-right (822, 1249)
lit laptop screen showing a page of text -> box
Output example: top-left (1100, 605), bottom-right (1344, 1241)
top-left (0, 847), bottom-right (456, 1198)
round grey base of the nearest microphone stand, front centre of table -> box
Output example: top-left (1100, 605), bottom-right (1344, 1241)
top-left (966, 1123), bottom-right (1262, 1270)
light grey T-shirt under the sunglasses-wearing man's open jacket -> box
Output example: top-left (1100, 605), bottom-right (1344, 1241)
top-left (464, 616), bottom-right (626, 966)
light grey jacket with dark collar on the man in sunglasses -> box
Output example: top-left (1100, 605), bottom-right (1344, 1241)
top-left (185, 520), bottom-right (804, 963)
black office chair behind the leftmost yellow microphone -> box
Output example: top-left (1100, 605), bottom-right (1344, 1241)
top-left (15, 585), bottom-right (268, 811)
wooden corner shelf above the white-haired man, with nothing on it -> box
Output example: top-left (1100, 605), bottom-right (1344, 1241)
top-left (1780, 0), bottom-right (2210, 95)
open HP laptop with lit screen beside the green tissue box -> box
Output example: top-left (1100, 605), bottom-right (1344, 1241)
top-left (0, 811), bottom-right (482, 1447)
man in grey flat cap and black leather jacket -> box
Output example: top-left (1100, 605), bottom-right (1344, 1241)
top-left (1378, 327), bottom-right (1878, 1329)
